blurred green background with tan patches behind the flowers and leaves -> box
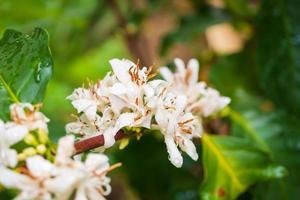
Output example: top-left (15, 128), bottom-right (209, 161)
top-left (0, 0), bottom-right (300, 200)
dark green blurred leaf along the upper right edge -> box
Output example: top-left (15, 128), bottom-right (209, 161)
top-left (257, 0), bottom-right (300, 116)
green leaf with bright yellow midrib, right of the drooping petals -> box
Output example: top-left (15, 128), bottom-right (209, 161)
top-left (200, 134), bottom-right (286, 199)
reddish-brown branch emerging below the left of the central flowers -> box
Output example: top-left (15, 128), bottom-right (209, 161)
top-left (74, 130), bottom-right (125, 155)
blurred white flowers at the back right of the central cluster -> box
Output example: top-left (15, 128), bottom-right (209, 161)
top-left (160, 58), bottom-right (230, 117)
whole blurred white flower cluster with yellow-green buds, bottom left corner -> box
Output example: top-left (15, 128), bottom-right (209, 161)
top-left (0, 103), bottom-right (116, 200)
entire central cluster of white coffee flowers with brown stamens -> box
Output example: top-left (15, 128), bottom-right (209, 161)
top-left (66, 59), bottom-right (230, 167)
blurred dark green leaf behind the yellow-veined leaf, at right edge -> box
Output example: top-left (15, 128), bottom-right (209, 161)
top-left (233, 110), bottom-right (300, 200)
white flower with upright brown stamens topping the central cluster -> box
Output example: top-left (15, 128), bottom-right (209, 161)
top-left (109, 59), bottom-right (153, 128)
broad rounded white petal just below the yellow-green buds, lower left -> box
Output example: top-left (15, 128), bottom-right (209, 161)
top-left (26, 155), bottom-right (54, 177)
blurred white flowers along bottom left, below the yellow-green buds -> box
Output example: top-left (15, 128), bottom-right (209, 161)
top-left (0, 136), bottom-right (111, 200)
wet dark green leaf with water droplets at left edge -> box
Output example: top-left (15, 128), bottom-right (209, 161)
top-left (0, 28), bottom-right (53, 119)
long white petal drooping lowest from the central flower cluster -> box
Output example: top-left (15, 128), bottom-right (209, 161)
top-left (165, 137), bottom-right (183, 168)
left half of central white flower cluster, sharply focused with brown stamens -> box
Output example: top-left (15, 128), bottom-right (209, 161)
top-left (66, 59), bottom-right (158, 148)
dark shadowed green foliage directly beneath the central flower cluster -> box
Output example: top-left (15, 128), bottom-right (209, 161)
top-left (115, 133), bottom-right (201, 200)
